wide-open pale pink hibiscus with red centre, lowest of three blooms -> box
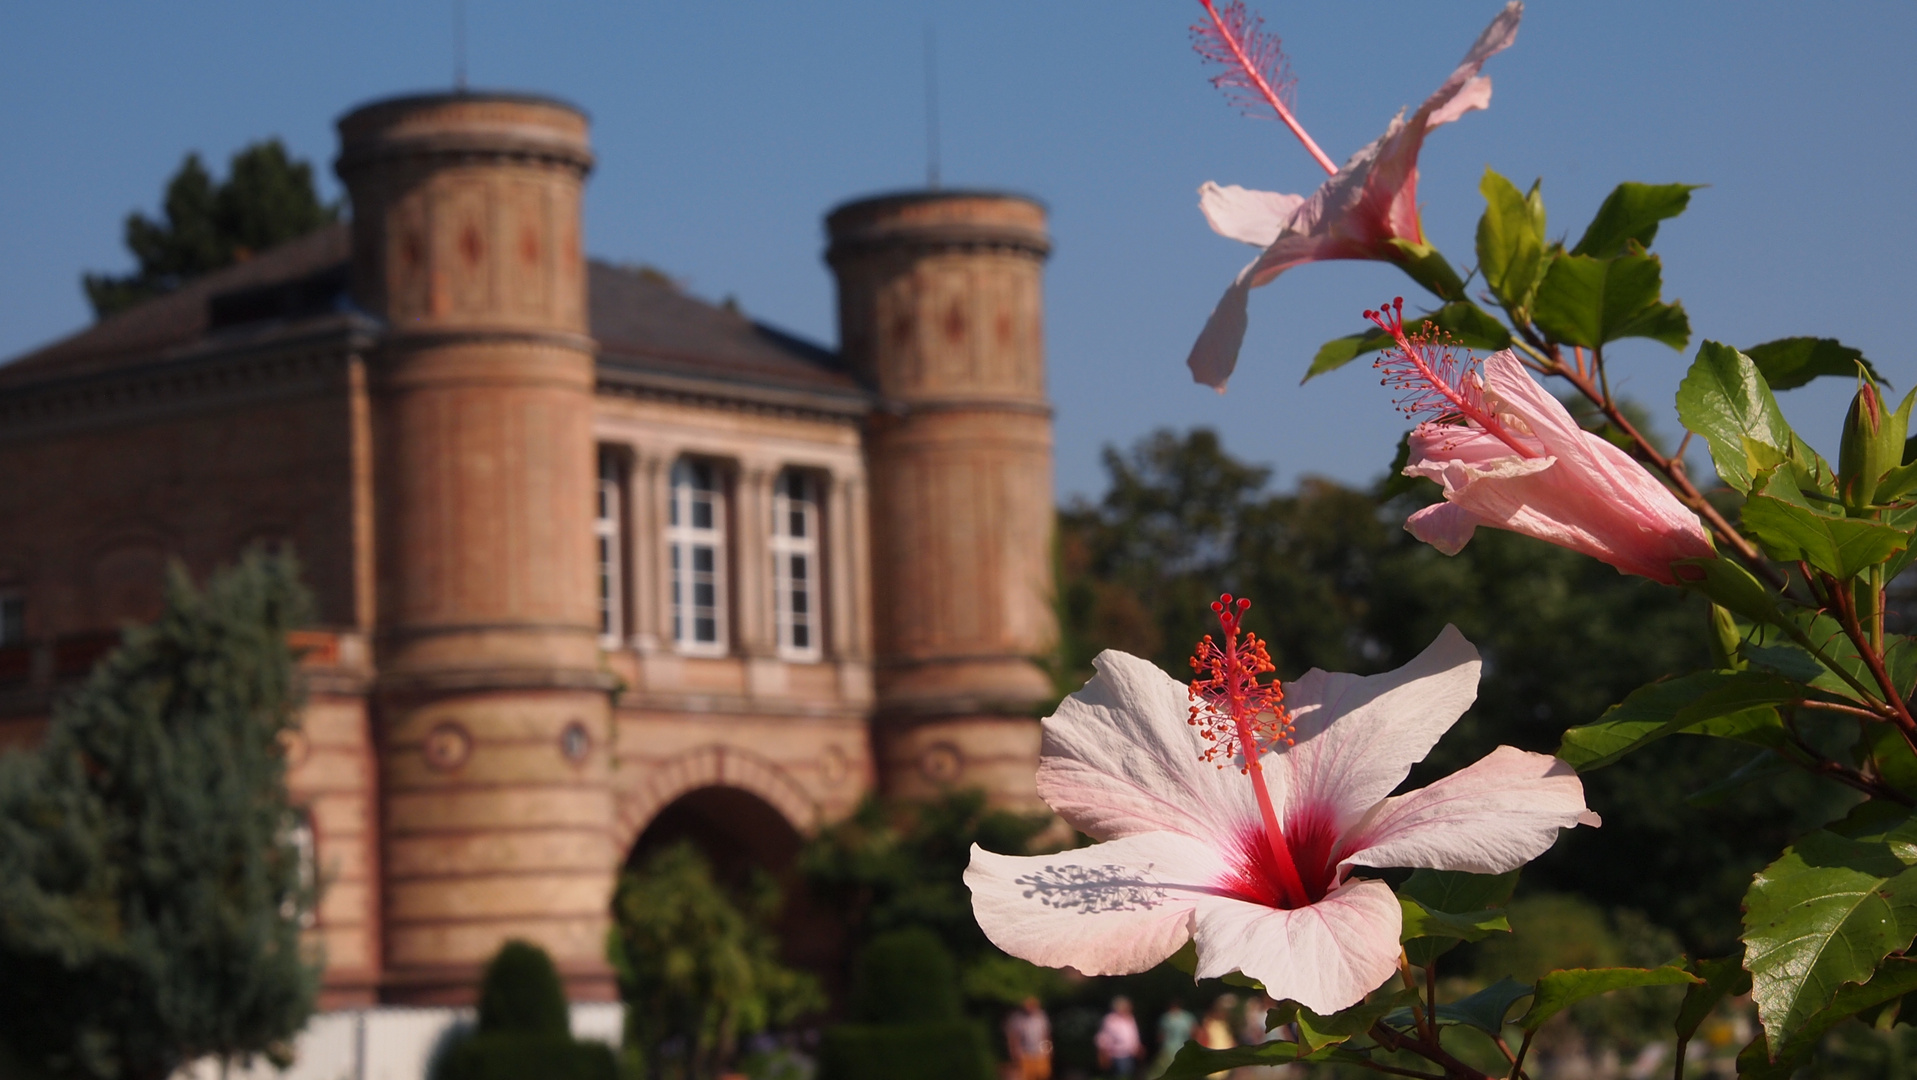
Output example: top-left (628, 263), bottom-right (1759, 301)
top-left (964, 597), bottom-right (1597, 1013)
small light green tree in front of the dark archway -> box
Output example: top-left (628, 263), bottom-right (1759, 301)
top-left (610, 842), bottom-right (826, 1080)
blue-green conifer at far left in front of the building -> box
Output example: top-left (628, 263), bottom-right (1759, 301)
top-left (0, 552), bottom-right (318, 1080)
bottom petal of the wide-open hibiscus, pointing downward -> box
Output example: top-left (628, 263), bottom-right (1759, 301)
top-left (1192, 880), bottom-right (1403, 1015)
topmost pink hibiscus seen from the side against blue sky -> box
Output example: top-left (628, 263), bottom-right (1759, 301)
top-left (1185, 0), bottom-right (1524, 391)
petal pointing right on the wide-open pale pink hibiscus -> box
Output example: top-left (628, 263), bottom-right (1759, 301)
top-left (1344, 746), bottom-right (1597, 873)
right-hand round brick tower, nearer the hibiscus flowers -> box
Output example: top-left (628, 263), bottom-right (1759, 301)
top-left (826, 192), bottom-right (1054, 808)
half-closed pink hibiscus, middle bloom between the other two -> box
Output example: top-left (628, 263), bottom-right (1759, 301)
top-left (1365, 299), bottom-right (1718, 585)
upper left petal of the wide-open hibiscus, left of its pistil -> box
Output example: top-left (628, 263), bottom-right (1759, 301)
top-left (1037, 650), bottom-right (1258, 840)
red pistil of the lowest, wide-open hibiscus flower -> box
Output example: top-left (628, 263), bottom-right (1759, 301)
top-left (1189, 593), bottom-right (1323, 907)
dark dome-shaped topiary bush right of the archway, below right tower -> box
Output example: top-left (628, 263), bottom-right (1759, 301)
top-left (819, 928), bottom-right (995, 1080)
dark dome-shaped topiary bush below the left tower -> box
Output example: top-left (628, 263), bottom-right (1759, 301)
top-left (433, 942), bottom-right (619, 1080)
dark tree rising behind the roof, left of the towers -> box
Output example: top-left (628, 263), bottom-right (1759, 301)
top-left (81, 138), bottom-right (339, 318)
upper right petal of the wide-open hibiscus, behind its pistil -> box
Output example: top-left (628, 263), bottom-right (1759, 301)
top-left (1272, 625), bottom-right (1480, 831)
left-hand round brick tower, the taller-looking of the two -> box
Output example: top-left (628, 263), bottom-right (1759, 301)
top-left (335, 94), bottom-right (619, 1003)
